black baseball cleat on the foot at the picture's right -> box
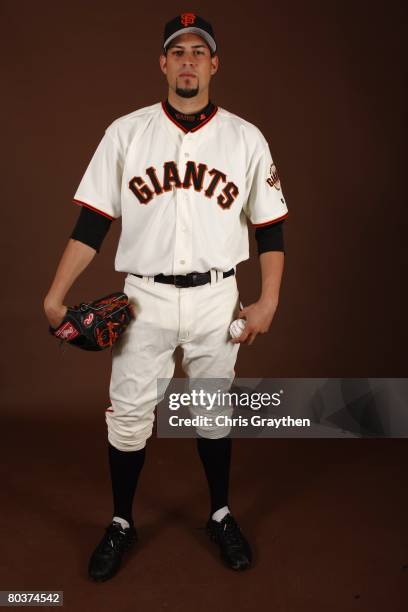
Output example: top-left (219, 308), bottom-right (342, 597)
top-left (206, 514), bottom-right (252, 570)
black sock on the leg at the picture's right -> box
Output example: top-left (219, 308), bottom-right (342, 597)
top-left (197, 437), bottom-right (232, 516)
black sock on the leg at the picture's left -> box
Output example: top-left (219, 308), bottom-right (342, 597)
top-left (108, 442), bottom-right (146, 525)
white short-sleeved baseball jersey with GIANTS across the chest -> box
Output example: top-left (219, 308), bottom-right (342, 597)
top-left (74, 103), bottom-right (287, 276)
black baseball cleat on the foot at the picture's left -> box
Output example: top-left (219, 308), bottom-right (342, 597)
top-left (88, 521), bottom-right (137, 582)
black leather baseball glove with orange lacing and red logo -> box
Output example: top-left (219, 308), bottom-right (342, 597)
top-left (49, 292), bottom-right (133, 351)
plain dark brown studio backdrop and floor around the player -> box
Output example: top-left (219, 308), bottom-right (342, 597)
top-left (0, 0), bottom-right (408, 612)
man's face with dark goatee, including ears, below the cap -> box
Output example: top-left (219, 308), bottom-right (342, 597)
top-left (160, 33), bottom-right (218, 98)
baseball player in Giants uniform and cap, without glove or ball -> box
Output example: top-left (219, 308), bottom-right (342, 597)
top-left (44, 13), bottom-right (287, 581)
